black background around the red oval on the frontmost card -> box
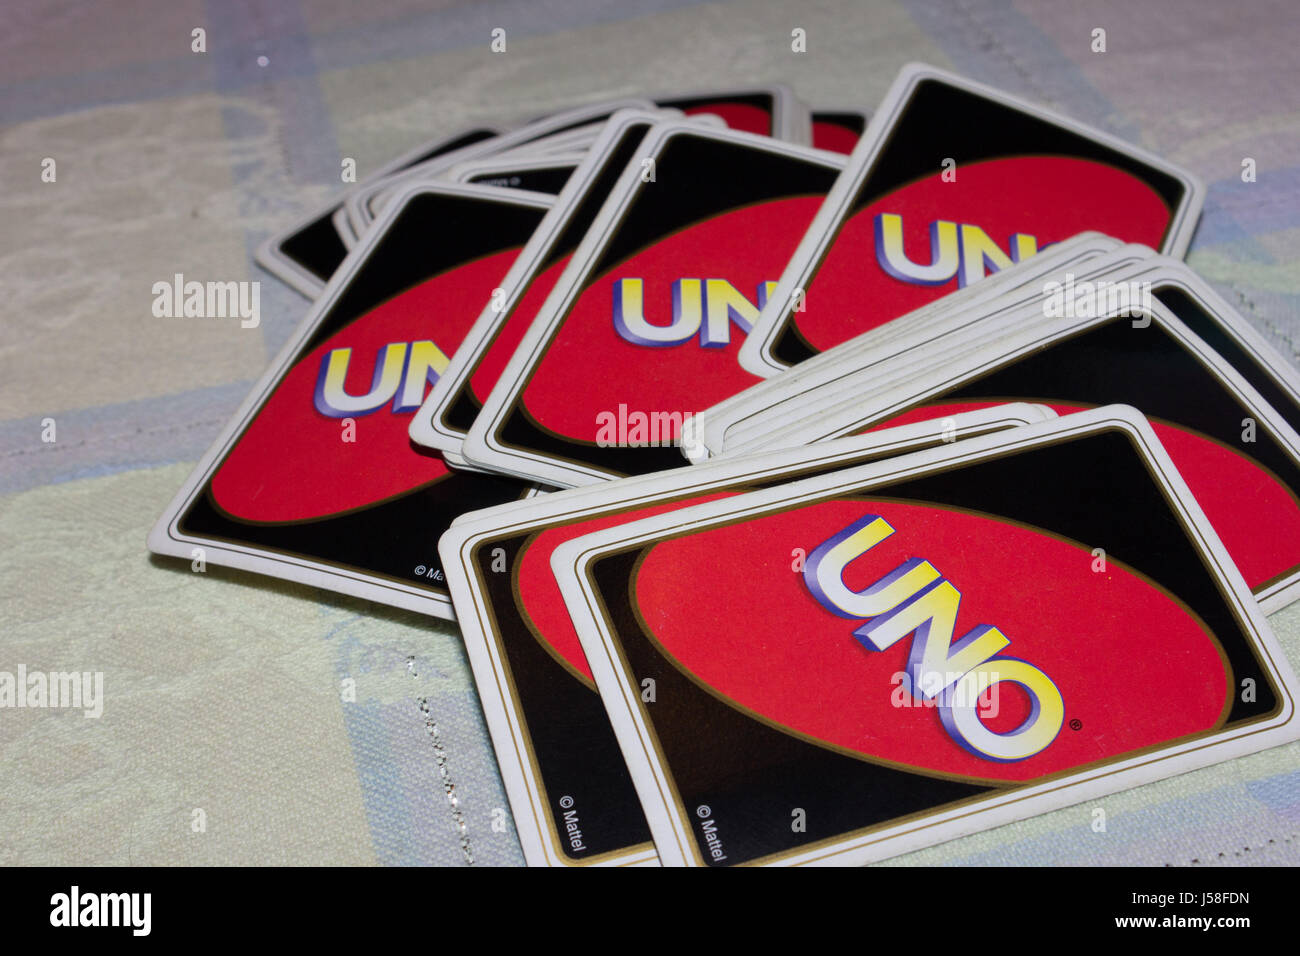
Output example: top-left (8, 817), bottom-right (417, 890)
top-left (592, 431), bottom-right (1278, 864)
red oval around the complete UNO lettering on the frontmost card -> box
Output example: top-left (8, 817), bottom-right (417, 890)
top-left (633, 501), bottom-right (1231, 782)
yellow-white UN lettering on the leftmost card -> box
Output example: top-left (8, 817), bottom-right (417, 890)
top-left (313, 339), bottom-right (449, 419)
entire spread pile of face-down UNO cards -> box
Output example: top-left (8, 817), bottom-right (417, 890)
top-left (150, 65), bottom-right (1300, 866)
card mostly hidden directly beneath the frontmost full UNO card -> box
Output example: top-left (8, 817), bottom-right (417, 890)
top-left (438, 406), bottom-right (1050, 866)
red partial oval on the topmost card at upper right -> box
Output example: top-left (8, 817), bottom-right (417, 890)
top-left (793, 156), bottom-right (1170, 351)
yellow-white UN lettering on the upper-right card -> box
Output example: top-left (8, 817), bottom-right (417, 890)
top-left (875, 212), bottom-right (1039, 289)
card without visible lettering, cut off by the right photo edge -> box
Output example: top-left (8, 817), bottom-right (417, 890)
top-left (750, 290), bottom-right (1300, 611)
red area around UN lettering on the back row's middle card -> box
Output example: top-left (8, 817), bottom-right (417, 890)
top-left (523, 196), bottom-right (822, 444)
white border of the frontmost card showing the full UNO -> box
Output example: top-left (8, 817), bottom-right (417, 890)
top-left (551, 406), bottom-right (1300, 866)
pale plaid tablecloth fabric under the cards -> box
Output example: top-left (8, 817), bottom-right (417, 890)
top-left (0, 0), bottom-right (1300, 865)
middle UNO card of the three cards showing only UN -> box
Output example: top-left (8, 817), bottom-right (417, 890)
top-left (462, 122), bottom-right (842, 485)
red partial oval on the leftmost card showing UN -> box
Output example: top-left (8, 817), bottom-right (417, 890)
top-left (212, 248), bottom-right (519, 522)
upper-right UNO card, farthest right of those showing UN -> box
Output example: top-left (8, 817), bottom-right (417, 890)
top-left (741, 65), bottom-right (1204, 375)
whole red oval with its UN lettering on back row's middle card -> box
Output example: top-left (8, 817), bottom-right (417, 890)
top-left (521, 195), bottom-right (822, 445)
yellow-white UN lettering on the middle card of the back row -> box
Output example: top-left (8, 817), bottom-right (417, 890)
top-left (614, 278), bottom-right (776, 349)
